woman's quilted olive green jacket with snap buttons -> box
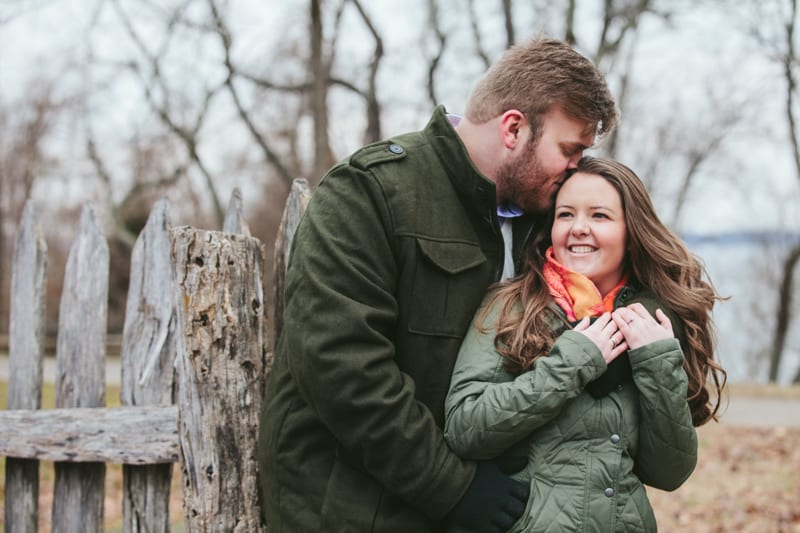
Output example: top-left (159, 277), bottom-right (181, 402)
top-left (445, 288), bottom-right (697, 533)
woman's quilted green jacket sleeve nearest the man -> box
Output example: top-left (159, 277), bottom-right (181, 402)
top-left (445, 302), bottom-right (606, 459)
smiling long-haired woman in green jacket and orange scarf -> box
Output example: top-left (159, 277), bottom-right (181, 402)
top-left (445, 158), bottom-right (725, 532)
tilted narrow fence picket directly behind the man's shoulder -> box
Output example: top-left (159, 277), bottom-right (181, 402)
top-left (270, 178), bottom-right (311, 350)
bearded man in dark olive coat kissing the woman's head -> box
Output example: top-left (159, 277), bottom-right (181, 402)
top-left (259, 39), bottom-right (617, 533)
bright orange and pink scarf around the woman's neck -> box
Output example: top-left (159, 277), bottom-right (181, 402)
top-left (542, 246), bottom-right (627, 322)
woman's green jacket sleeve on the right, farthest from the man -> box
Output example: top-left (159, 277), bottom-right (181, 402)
top-left (629, 339), bottom-right (697, 490)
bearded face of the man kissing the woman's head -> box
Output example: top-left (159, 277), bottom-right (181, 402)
top-left (497, 107), bottom-right (595, 212)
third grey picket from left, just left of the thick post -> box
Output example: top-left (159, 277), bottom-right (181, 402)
top-left (120, 200), bottom-right (176, 533)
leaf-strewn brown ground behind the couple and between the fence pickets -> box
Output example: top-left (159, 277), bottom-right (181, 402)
top-left (0, 380), bottom-right (800, 533)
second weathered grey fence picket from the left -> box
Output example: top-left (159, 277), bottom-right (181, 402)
top-left (53, 204), bottom-right (109, 533)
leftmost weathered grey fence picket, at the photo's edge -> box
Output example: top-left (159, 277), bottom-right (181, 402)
top-left (5, 201), bottom-right (47, 533)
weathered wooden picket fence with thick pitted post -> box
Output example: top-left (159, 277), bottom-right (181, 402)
top-left (0, 180), bottom-right (310, 533)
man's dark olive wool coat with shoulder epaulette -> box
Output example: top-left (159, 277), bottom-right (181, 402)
top-left (259, 107), bottom-right (531, 533)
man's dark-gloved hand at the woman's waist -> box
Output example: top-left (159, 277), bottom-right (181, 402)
top-left (447, 461), bottom-right (530, 533)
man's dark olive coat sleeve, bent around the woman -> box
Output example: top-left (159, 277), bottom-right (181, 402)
top-left (281, 165), bottom-right (474, 517)
